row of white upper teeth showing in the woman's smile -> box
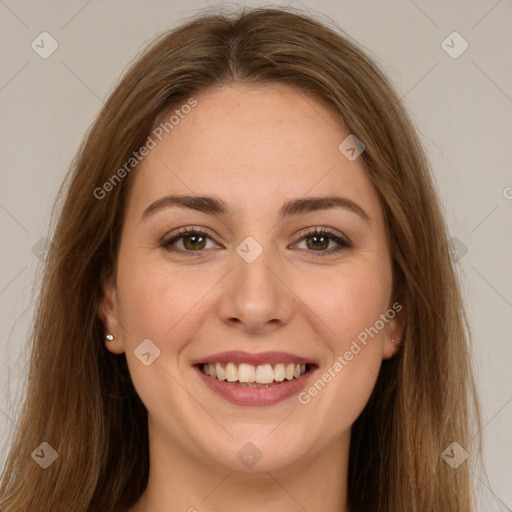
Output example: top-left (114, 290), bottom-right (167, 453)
top-left (202, 363), bottom-right (306, 387)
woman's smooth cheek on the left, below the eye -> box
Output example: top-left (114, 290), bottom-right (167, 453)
top-left (118, 251), bottom-right (205, 420)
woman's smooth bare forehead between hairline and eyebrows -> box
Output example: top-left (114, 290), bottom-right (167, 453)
top-left (124, 84), bottom-right (378, 220)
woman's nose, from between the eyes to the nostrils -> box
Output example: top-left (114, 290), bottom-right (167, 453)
top-left (218, 241), bottom-right (296, 334)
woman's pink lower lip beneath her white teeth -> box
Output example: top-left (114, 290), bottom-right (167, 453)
top-left (195, 366), bottom-right (316, 406)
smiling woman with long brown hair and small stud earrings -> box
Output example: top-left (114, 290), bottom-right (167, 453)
top-left (1, 5), bottom-right (479, 512)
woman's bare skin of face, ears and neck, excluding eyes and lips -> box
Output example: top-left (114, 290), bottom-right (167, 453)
top-left (101, 84), bottom-right (403, 512)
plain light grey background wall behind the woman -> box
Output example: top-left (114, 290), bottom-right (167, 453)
top-left (0, 0), bottom-right (512, 512)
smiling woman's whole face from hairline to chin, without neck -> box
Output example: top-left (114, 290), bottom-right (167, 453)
top-left (101, 81), bottom-right (402, 471)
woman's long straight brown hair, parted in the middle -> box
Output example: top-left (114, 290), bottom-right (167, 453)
top-left (0, 8), bottom-right (480, 512)
